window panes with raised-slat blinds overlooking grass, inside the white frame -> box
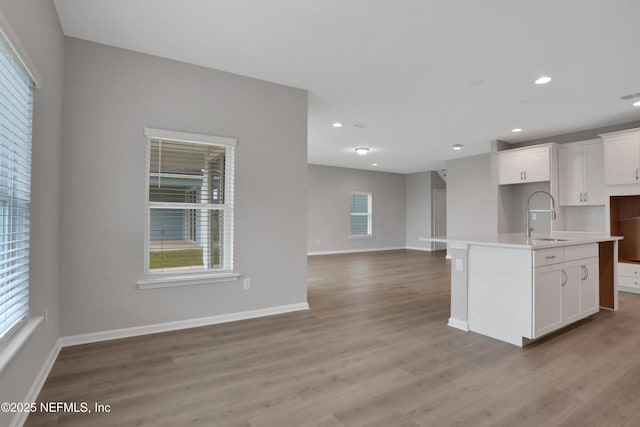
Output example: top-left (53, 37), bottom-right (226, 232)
top-left (146, 134), bottom-right (234, 274)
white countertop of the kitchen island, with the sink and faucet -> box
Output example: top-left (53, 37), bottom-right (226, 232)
top-left (428, 232), bottom-right (623, 249)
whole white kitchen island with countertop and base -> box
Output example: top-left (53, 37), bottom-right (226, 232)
top-left (432, 234), bottom-right (620, 346)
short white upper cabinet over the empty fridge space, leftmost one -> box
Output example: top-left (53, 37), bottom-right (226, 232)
top-left (498, 145), bottom-right (551, 185)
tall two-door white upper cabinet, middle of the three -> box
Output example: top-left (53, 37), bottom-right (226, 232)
top-left (558, 140), bottom-right (605, 206)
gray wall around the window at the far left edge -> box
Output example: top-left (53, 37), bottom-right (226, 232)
top-left (0, 0), bottom-right (64, 426)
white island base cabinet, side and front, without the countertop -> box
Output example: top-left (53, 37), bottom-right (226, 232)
top-left (464, 243), bottom-right (600, 346)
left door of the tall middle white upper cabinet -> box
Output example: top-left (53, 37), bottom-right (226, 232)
top-left (558, 146), bottom-right (584, 206)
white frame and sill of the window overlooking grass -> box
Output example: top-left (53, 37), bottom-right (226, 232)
top-left (137, 128), bottom-right (240, 289)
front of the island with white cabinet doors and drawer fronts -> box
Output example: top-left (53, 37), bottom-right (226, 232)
top-left (533, 244), bottom-right (600, 338)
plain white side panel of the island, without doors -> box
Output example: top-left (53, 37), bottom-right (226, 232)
top-left (468, 245), bottom-right (533, 346)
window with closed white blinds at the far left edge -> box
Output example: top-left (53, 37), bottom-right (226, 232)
top-left (0, 36), bottom-right (34, 338)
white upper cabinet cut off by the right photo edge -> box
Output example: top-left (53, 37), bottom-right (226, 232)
top-left (600, 129), bottom-right (640, 185)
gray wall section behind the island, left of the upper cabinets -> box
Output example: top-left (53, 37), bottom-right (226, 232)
top-left (447, 153), bottom-right (498, 237)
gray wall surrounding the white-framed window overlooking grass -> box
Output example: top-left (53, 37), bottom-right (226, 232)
top-left (61, 38), bottom-right (307, 335)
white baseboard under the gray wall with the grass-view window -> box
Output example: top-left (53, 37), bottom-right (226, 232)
top-left (60, 302), bottom-right (309, 347)
